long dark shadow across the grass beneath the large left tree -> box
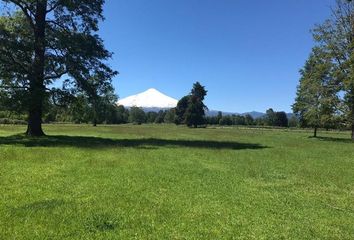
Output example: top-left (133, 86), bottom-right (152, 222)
top-left (0, 134), bottom-right (267, 150)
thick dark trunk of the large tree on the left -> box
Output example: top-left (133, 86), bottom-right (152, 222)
top-left (26, 0), bottom-right (47, 136)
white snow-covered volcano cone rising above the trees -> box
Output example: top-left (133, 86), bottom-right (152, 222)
top-left (117, 88), bottom-right (178, 109)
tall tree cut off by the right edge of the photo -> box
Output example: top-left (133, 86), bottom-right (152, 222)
top-left (313, 0), bottom-right (354, 140)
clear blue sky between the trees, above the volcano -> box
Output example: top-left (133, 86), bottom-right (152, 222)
top-left (100, 0), bottom-right (335, 112)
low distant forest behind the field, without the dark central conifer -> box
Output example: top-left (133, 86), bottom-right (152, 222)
top-left (0, 102), bottom-right (345, 129)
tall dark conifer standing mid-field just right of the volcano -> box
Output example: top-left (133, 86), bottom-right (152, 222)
top-left (184, 82), bottom-right (207, 128)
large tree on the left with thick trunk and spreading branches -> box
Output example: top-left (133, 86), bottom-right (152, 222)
top-left (0, 0), bottom-right (117, 136)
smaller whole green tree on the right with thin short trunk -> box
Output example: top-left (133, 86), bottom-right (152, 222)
top-left (293, 48), bottom-right (338, 137)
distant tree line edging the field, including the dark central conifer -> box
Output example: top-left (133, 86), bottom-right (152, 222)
top-left (0, 79), bottom-right (299, 127)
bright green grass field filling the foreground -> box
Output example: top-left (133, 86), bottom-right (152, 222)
top-left (0, 125), bottom-right (354, 240)
